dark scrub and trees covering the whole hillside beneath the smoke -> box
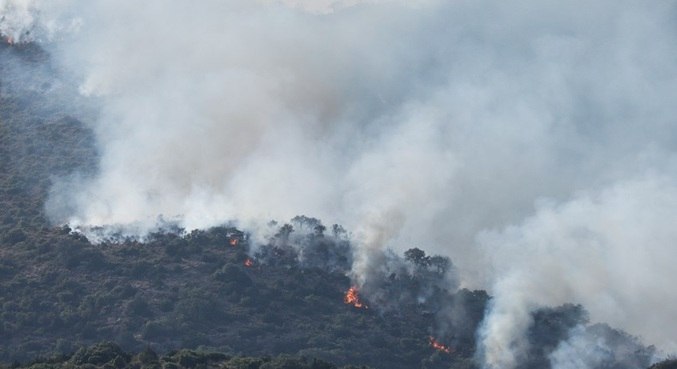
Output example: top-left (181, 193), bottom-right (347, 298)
top-left (0, 38), bottom-right (664, 369)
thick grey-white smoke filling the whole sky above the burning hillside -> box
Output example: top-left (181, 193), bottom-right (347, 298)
top-left (0, 0), bottom-right (677, 368)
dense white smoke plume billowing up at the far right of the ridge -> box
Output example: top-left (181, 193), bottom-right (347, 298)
top-left (480, 173), bottom-right (677, 368)
